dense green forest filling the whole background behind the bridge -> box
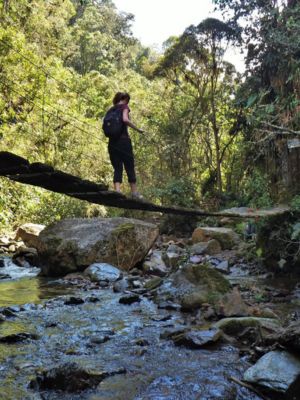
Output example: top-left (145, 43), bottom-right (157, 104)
top-left (0, 0), bottom-right (300, 228)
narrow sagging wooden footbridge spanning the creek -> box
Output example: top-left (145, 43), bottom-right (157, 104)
top-left (0, 151), bottom-right (289, 218)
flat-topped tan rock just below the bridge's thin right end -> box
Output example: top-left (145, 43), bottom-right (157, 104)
top-left (192, 227), bottom-right (239, 250)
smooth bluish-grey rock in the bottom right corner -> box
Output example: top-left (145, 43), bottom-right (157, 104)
top-left (244, 351), bottom-right (300, 399)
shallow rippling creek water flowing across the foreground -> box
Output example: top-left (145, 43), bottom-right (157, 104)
top-left (0, 258), bottom-right (298, 400)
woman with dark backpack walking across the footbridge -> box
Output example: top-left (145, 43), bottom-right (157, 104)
top-left (103, 92), bottom-right (143, 199)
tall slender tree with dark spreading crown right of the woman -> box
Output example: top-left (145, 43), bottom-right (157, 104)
top-left (159, 18), bottom-right (238, 192)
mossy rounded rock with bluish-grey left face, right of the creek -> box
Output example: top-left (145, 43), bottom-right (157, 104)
top-left (158, 264), bottom-right (230, 311)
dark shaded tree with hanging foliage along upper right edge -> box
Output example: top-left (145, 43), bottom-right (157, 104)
top-left (214, 0), bottom-right (300, 201)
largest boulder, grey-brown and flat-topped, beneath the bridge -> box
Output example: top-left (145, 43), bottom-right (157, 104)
top-left (36, 218), bottom-right (158, 276)
